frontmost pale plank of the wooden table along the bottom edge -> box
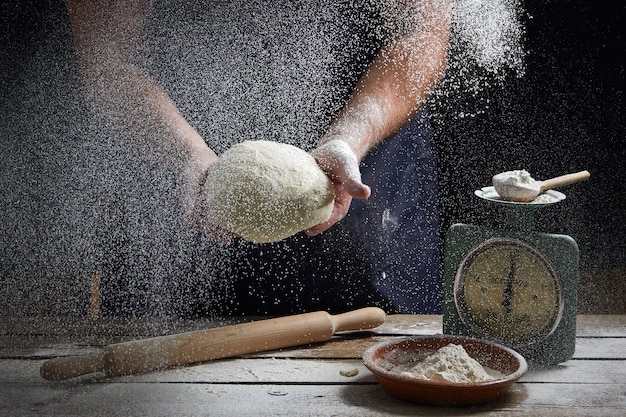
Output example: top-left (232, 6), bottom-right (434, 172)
top-left (0, 383), bottom-right (626, 417)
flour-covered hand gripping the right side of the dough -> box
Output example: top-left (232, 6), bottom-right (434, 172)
top-left (304, 139), bottom-right (371, 236)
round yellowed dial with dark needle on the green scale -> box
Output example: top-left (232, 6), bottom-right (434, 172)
top-left (454, 237), bottom-right (563, 347)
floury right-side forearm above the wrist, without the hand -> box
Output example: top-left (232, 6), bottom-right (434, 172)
top-left (322, 1), bottom-right (450, 160)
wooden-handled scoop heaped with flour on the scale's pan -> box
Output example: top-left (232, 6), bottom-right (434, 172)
top-left (493, 171), bottom-right (590, 202)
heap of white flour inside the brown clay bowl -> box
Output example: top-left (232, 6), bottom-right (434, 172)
top-left (396, 343), bottom-right (496, 382)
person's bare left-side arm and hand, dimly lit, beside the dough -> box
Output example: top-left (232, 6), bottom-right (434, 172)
top-left (68, 0), bottom-right (229, 240)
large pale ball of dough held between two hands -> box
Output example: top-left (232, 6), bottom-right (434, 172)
top-left (205, 140), bottom-right (335, 243)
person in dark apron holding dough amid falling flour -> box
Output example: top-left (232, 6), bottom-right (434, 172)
top-left (68, 0), bottom-right (450, 314)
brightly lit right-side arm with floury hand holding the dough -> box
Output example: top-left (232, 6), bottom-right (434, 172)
top-left (306, 0), bottom-right (451, 235)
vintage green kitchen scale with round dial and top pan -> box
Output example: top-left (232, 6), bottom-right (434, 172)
top-left (443, 187), bottom-right (579, 365)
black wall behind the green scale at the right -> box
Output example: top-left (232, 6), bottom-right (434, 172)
top-left (436, 0), bottom-right (626, 268)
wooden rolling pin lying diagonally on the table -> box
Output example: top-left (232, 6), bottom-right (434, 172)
top-left (40, 307), bottom-right (385, 381)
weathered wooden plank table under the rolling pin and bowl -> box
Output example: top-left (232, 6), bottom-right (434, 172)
top-left (0, 315), bottom-right (626, 417)
